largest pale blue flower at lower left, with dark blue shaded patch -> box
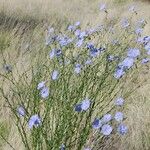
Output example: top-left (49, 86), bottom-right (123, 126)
top-left (28, 114), bottom-right (42, 129)
